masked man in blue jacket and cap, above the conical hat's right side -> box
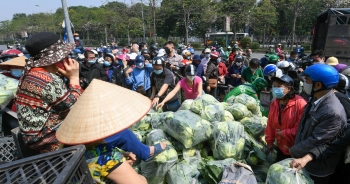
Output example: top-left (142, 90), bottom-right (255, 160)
top-left (125, 55), bottom-right (153, 97)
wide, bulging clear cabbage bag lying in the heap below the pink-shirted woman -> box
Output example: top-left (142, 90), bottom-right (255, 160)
top-left (164, 110), bottom-right (212, 148)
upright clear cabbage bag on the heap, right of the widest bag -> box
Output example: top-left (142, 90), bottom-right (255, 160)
top-left (213, 121), bottom-right (245, 160)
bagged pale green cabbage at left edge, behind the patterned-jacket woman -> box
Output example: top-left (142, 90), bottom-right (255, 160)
top-left (0, 74), bottom-right (18, 109)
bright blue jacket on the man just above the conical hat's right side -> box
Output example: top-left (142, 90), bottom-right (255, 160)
top-left (125, 63), bottom-right (153, 91)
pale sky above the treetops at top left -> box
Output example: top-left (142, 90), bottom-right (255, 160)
top-left (0, 0), bottom-right (135, 21)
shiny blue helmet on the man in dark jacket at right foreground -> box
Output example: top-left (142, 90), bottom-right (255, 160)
top-left (301, 64), bottom-right (339, 89)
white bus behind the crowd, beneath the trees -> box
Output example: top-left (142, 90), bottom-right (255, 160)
top-left (206, 32), bottom-right (249, 46)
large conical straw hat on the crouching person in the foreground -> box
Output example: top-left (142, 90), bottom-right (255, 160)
top-left (56, 79), bottom-right (151, 145)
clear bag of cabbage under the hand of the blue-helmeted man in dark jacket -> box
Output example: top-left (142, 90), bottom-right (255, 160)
top-left (266, 158), bottom-right (314, 184)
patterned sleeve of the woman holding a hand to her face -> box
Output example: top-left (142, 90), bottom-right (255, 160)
top-left (42, 75), bottom-right (83, 113)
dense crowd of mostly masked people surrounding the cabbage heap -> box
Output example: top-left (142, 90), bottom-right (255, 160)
top-left (0, 32), bottom-right (350, 184)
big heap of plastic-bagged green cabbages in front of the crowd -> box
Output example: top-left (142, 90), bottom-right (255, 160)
top-left (130, 94), bottom-right (307, 184)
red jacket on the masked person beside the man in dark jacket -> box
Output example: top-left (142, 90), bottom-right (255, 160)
top-left (265, 95), bottom-right (306, 155)
